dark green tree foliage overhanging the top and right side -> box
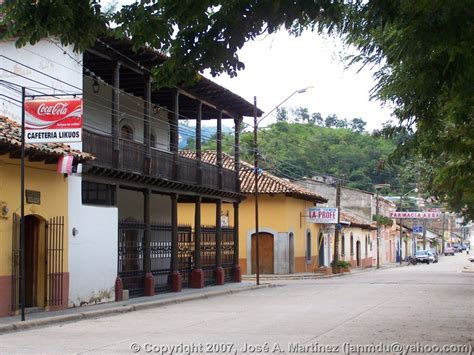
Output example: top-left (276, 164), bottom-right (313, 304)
top-left (2, 0), bottom-right (474, 219)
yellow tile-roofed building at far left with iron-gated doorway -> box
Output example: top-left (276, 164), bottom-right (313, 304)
top-left (0, 116), bottom-right (91, 316)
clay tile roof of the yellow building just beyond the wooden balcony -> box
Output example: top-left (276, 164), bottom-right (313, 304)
top-left (180, 150), bottom-right (327, 203)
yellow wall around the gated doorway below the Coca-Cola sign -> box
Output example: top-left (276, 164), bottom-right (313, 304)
top-left (0, 155), bottom-right (68, 312)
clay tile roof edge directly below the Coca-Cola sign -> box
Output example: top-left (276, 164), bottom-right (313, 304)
top-left (0, 116), bottom-right (95, 162)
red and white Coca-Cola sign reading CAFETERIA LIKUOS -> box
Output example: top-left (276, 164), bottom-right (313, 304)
top-left (25, 99), bottom-right (82, 143)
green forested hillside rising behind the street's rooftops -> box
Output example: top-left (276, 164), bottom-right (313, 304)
top-left (194, 108), bottom-right (414, 195)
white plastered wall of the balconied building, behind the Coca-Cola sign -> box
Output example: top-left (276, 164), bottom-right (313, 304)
top-left (0, 40), bottom-right (118, 306)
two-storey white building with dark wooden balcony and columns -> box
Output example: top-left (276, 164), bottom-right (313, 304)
top-left (0, 38), bottom-right (261, 306)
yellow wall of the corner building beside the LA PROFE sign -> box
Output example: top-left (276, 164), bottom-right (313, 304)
top-left (178, 194), bottom-right (320, 274)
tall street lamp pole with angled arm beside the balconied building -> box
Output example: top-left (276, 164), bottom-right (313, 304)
top-left (253, 86), bottom-right (312, 285)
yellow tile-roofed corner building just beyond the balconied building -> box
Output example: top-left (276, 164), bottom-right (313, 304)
top-left (179, 151), bottom-right (329, 274)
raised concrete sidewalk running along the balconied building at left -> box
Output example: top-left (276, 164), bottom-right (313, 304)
top-left (0, 281), bottom-right (271, 334)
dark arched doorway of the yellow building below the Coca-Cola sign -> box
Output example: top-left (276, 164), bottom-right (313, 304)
top-left (25, 215), bottom-right (40, 307)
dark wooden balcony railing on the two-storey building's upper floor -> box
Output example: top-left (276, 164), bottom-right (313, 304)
top-left (83, 130), bottom-right (238, 193)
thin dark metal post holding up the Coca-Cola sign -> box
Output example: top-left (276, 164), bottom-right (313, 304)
top-left (20, 86), bottom-right (26, 322)
